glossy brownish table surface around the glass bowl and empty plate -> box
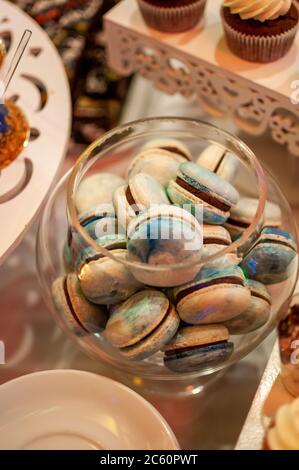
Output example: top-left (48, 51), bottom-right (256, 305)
top-left (0, 77), bottom-right (299, 449)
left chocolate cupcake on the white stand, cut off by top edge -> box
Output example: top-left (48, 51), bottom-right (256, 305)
top-left (138, 0), bottom-right (206, 33)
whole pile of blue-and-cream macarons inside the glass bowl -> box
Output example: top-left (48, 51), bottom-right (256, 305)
top-left (52, 139), bottom-right (297, 373)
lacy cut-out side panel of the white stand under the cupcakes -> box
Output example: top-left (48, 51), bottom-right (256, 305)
top-left (106, 21), bottom-right (299, 156)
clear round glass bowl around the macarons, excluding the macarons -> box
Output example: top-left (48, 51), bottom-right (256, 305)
top-left (37, 118), bottom-right (298, 388)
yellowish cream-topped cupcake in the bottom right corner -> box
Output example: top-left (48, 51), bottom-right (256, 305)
top-left (264, 398), bottom-right (299, 450)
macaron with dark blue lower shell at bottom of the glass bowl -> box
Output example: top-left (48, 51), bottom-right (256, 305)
top-left (164, 325), bottom-right (234, 373)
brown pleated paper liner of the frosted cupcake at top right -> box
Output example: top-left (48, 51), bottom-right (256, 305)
top-left (221, 9), bottom-right (298, 63)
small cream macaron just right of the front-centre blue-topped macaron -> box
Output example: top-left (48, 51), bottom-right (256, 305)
top-left (202, 224), bottom-right (241, 269)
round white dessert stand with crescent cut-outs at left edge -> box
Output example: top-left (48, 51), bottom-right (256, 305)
top-left (0, 0), bottom-right (71, 264)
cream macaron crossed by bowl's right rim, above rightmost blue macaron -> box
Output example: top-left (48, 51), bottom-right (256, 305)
top-left (225, 197), bottom-right (281, 240)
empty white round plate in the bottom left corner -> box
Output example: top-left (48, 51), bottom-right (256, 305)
top-left (0, 370), bottom-right (179, 450)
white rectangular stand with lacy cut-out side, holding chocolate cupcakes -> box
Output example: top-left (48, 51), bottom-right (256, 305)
top-left (105, 0), bottom-right (299, 156)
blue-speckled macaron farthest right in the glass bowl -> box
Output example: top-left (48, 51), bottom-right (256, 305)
top-left (240, 227), bottom-right (298, 285)
